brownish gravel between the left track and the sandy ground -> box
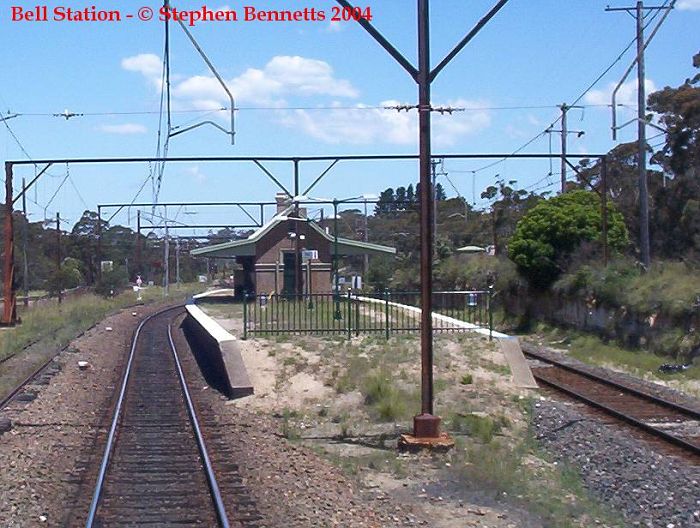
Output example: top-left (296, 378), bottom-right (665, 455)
top-left (175, 318), bottom-right (430, 528)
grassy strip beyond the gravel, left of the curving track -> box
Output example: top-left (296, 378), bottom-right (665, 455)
top-left (0, 284), bottom-right (201, 396)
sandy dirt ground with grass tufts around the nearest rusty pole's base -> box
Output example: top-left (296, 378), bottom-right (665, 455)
top-left (203, 305), bottom-right (606, 528)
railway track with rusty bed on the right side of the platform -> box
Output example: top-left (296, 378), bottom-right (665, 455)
top-left (523, 347), bottom-right (700, 456)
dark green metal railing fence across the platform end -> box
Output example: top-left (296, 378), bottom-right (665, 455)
top-left (243, 291), bottom-right (493, 339)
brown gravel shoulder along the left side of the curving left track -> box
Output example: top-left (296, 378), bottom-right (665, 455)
top-left (0, 306), bottom-right (176, 528)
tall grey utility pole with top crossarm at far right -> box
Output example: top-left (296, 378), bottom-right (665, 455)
top-left (606, 0), bottom-right (675, 268)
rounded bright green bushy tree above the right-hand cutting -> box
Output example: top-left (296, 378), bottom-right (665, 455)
top-left (508, 190), bottom-right (628, 288)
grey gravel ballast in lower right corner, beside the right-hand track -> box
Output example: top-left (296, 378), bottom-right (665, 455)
top-left (533, 400), bottom-right (700, 528)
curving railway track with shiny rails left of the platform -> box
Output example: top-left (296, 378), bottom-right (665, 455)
top-left (86, 307), bottom-right (229, 528)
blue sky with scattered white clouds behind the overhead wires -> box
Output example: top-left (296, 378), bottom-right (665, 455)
top-left (0, 0), bottom-right (700, 233)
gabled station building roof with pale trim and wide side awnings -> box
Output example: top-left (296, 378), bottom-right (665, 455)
top-left (190, 206), bottom-right (396, 258)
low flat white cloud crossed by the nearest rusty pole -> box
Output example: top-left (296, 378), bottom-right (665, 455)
top-left (280, 99), bottom-right (491, 147)
